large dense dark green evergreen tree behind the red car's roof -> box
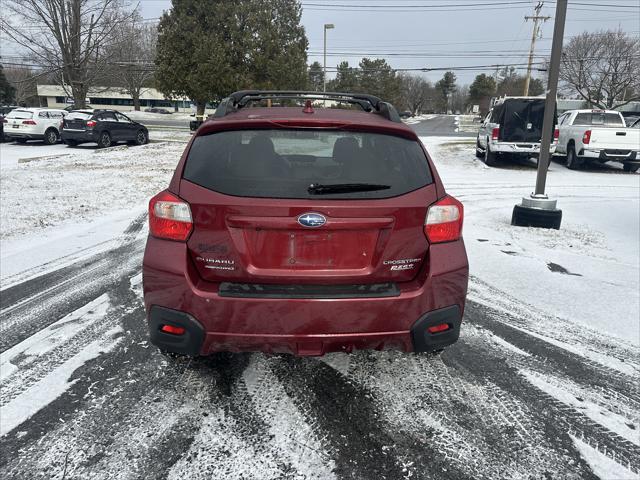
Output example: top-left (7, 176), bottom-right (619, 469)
top-left (156, 0), bottom-right (307, 115)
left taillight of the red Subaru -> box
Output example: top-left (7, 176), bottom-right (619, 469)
top-left (149, 191), bottom-right (193, 242)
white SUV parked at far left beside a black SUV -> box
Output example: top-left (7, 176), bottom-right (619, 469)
top-left (4, 108), bottom-right (67, 145)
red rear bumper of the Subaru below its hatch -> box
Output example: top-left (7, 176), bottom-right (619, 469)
top-left (143, 237), bottom-right (468, 355)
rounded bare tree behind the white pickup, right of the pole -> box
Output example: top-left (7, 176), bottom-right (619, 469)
top-left (560, 30), bottom-right (640, 109)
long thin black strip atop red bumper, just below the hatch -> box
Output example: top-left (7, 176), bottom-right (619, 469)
top-left (218, 282), bottom-right (400, 299)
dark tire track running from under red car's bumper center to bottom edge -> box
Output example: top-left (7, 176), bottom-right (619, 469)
top-left (271, 357), bottom-right (471, 479)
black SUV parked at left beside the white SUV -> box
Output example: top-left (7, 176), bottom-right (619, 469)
top-left (62, 110), bottom-right (149, 148)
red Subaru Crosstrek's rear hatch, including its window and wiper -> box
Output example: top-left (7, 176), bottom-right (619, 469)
top-left (179, 128), bottom-right (436, 284)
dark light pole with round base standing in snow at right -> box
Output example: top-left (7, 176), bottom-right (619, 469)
top-left (511, 0), bottom-right (567, 229)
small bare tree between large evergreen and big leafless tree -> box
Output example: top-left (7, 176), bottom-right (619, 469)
top-left (112, 12), bottom-right (158, 110)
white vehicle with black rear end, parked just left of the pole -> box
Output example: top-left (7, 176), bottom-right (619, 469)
top-left (476, 97), bottom-right (557, 166)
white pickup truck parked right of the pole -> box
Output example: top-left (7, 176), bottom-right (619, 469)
top-left (556, 110), bottom-right (640, 172)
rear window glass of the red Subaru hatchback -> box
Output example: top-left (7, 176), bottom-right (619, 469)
top-left (183, 130), bottom-right (432, 199)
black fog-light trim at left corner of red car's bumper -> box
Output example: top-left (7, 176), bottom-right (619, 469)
top-left (149, 305), bottom-right (205, 356)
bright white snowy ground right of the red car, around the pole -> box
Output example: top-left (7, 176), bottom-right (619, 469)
top-left (422, 137), bottom-right (640, 345)
